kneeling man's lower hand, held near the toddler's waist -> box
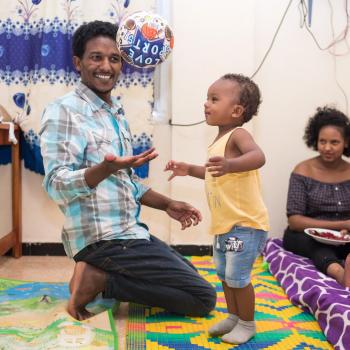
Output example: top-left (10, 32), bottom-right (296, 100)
top-left (166, 200), bottom-right (202, 230)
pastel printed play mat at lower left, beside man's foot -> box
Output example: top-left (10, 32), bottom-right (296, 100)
top-left (0, 278), bottom-right (118, 350)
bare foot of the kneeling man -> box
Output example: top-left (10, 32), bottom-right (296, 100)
top-left (67, 261), bottom-right (106, 320)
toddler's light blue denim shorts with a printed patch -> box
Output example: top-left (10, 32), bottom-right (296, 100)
top-left (213, 226), bottom-right (267, 288)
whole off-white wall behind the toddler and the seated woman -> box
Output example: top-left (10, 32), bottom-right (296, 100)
top-left (167, 0), bottom-right (350, 243)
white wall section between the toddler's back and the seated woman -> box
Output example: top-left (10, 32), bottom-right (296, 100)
top-left (254, 0), bottom-right (350, 236)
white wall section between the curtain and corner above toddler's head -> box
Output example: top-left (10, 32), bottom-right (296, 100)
top-left (171, 0), bottom-right (254, 244)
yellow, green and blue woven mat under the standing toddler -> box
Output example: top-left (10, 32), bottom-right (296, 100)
top-left (125, 257), bottom-right (333, 350)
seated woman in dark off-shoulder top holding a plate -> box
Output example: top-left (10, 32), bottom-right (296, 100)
top-left (283, 107), bottom-right (350, 287)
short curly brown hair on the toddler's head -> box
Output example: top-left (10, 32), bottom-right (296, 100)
top-left (221, 73), bottom-right (261, 123)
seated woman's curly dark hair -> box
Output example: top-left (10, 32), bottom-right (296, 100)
top-left (303, 106), bottom-right (350, 157)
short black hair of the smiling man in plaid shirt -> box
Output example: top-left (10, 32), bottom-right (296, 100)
top-left (72, 21), bottom-right (118, 58)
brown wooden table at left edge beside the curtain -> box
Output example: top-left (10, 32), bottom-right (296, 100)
top-left (0, 123), bottom-right (22, 258)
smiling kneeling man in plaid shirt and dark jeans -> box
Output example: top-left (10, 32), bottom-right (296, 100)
top-left (40, 21), bottom-right (216, 320)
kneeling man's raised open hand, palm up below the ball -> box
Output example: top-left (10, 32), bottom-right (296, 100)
top-left (104, 147), bottom-right (158, 173)
